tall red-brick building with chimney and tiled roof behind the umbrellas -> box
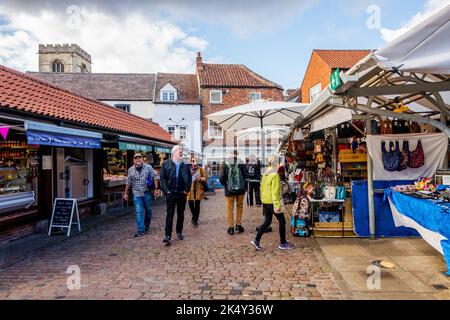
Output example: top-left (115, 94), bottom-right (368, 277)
top-left (196, 53), bottom-right (284, 162)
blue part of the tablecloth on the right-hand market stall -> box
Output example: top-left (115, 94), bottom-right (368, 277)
top-left (385, 189), bottom-right (450, 274)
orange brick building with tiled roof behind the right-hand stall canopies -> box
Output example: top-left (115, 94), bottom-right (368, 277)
top-left (298, 49), bottom-right (370, 103)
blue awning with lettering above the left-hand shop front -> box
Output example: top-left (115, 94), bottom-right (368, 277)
top-left (27, 130), bottom-right (101, 149)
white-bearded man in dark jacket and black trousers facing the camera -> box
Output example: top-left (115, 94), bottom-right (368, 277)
top-left (160, 146), bottom-right (192, 245)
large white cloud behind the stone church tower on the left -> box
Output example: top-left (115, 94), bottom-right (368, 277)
top-left (0, 6), bottom-right (208, 72)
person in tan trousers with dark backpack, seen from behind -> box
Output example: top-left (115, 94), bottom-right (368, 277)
top-left (219, 150), bottom-right (247, 235)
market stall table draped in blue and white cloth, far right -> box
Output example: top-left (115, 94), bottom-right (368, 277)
top-left (385, 189), bottom-right (450, 276)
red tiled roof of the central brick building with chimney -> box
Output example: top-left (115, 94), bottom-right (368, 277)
top-left (198, 63), bottom-right (282, 89)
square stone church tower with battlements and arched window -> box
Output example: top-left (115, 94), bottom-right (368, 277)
top-left (39, 44), bottom-right (92, 73)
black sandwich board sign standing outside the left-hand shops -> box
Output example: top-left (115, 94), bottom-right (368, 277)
top-left (48, 198), bottom-right (81, 236)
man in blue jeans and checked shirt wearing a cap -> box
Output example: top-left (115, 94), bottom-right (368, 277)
top-left (123, 153), bottom-right (159, 237)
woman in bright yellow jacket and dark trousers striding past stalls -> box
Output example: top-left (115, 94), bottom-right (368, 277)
top-left (251, 155), bottom-right (294, 251)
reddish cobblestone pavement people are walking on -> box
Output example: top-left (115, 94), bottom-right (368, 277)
top-left (0, 192), bottom-right (344, 300)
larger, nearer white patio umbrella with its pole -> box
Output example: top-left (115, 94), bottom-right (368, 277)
top-left (206, 100), bottom-right (308, 163)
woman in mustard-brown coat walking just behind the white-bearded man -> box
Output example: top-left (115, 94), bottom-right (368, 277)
top-left (187, 157), bottom-right (206, 228)
